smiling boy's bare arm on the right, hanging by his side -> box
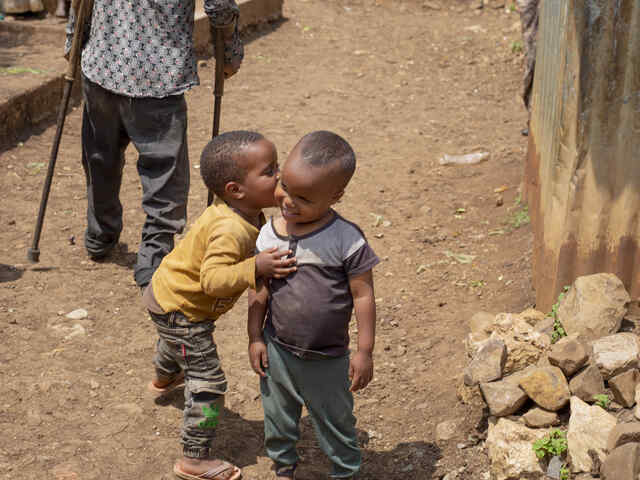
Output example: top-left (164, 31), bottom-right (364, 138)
top-left (349, 270), bottom-right (376, 392)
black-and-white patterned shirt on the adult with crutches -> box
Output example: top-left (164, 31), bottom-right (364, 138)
top-left (65, 0), bottom-right (243, 98)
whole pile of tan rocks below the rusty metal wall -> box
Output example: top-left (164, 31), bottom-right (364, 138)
top-left (464, 274), bottom-right (640, 480)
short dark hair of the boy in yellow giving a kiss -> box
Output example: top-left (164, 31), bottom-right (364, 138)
top-left (200, 130), bottom-right (264, 198)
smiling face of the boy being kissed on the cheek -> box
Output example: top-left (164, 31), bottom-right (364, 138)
top-left (275, 147), bottom-right (343, 224)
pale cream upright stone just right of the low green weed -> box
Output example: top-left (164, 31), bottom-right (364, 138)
top-left (567, 397), bottom-right (617, 473)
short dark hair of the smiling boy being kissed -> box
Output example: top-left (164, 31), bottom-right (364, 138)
top-left (298, 130), bottom-right (356, 188)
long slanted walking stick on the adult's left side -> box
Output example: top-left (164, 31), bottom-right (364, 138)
top-left (27, 0), bottom-right (93, 263)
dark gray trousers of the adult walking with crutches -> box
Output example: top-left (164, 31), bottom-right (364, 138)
top-left (82, 77), bottom-right (189, 286)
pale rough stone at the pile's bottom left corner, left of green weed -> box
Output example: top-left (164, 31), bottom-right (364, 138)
top-left (485, 418), bottom-right (549, 480)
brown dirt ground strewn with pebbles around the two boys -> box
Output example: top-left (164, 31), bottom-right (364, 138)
top-left (0, 0), bottom-right (534, 480)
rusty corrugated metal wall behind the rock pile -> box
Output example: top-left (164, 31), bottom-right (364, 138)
top-left (525, 0), bottom-right (640, 311)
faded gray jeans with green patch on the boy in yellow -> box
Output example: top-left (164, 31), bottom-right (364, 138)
top-left (149, 312), bottom-right (227, 458)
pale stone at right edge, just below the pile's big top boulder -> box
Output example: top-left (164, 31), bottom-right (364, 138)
top-left (591, 332), bottom-right (640, 380)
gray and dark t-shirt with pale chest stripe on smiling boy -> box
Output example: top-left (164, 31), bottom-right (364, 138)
top-left (256, 212), bottom-right (380, 358)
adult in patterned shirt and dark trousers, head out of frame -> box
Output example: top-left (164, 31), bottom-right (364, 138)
top-left (65, 0), bottom-right (244, 288)
